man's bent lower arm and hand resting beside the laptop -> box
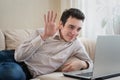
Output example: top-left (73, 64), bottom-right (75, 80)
top-left (61, 42), bottom-right (93, 72)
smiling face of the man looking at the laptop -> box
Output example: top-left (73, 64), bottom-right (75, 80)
top-left (60, 17), bottom-right (83, 42)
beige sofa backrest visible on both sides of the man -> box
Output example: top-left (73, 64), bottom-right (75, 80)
top-left (0, 29), bottom-right (95, 59)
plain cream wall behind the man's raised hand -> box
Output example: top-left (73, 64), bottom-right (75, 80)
top-left (0, 0), bottom-right (60, 29)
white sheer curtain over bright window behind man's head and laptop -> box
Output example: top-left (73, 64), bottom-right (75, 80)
top-left (61, 0), bottom-right (120, 39)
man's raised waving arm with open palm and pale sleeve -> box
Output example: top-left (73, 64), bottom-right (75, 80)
top-left (15, 11), bottom-right (57, 61)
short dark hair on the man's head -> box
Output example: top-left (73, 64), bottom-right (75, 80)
top-left (60, 8), bottom-right (85, 26)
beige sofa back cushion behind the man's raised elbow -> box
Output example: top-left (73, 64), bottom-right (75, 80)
top-left (3, 29), bottom-right (34, 50)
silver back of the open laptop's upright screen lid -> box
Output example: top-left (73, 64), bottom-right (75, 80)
top-left (93, 35), bottom-right (120, 78)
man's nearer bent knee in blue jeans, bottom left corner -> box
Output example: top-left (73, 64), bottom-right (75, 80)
top-left (0, 62), bottom-right (26, 80)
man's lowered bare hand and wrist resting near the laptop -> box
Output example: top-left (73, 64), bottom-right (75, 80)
top-left (62, 60), bottom-right (88, 72)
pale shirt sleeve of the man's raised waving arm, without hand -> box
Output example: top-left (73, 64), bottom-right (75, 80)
top-left (14, 30), bottom-right (44, 62)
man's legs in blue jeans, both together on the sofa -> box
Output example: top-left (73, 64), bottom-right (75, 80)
top-left (0, 50), bottom-right (26, 80)
